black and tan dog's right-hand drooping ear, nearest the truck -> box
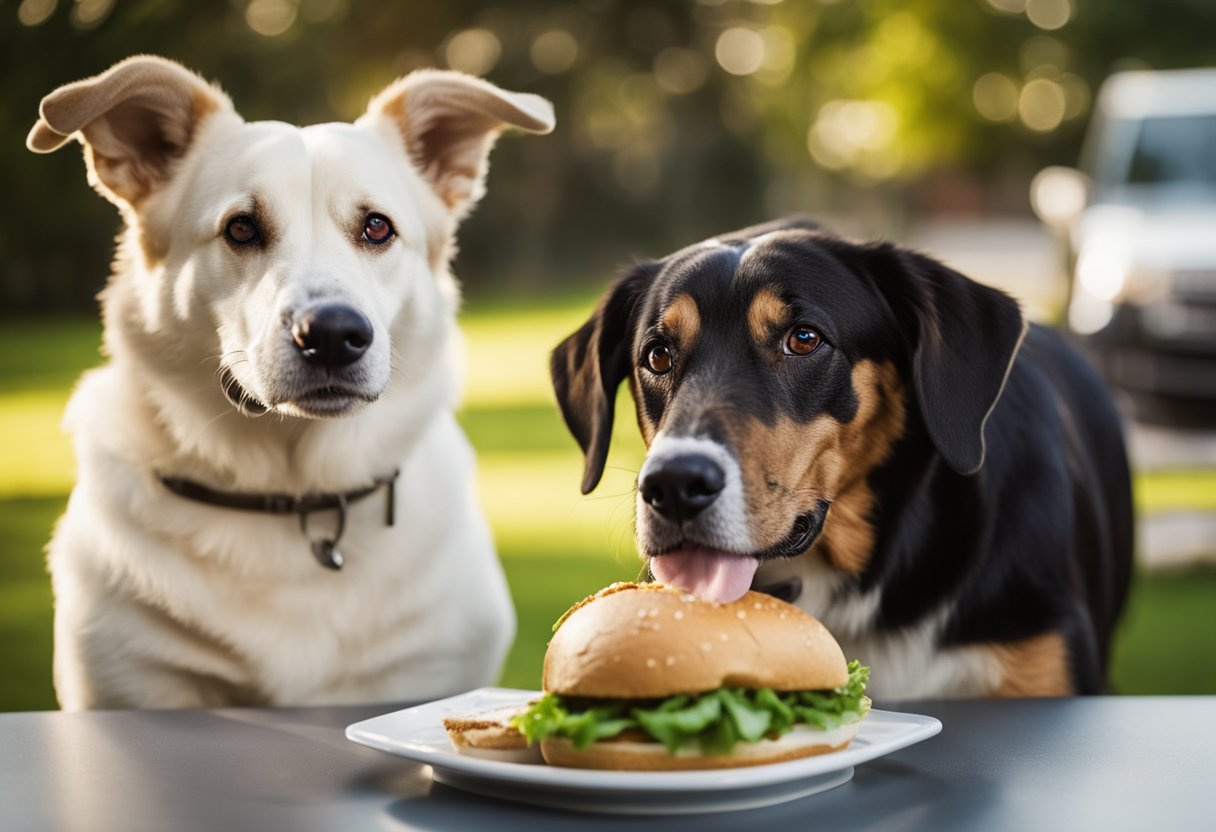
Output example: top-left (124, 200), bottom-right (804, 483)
top-left (867, 243), bottom-right (1026, 474)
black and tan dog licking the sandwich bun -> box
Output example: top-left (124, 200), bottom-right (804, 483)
top-left (552, 220), bottom-right (1132, 697)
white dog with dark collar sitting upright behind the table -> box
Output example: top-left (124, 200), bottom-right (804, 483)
top-left (28, 57), bottom-right (553, 709)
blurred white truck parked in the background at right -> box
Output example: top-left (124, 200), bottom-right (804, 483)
top-left (1031, 68), bottom-right (1216, 427)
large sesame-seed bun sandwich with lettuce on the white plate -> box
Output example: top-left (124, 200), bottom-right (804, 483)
top-left (512, 584), bottom-right (869, 771)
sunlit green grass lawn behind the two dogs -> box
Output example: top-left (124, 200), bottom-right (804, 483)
top-left (0, 308), bottom-right (1216, 710)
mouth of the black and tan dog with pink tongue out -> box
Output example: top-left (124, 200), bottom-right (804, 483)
top-left (648, 500), bottom-right (832, 603)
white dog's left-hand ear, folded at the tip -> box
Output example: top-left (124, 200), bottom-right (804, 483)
top-left (26, 55), bottom-right (232, 207)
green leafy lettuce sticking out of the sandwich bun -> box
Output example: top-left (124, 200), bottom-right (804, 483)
top-left (512, 660), bottom-right (869, 754)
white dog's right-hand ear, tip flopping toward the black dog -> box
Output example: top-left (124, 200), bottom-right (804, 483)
top-left (367, 69), bottom-right (553, 219)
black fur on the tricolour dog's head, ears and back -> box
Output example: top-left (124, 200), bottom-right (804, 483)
top-left (552, 220), bottom-right (1132, 693)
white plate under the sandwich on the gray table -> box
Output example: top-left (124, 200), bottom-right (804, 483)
top-left (347, 687), bottom-right (941, 815)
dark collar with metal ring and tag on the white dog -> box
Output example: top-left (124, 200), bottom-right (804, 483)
top-left (159, 468), bottom-right (400, 569)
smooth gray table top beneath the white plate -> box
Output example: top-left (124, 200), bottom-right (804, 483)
top-left (0, 697), bottom-right (1216, 832)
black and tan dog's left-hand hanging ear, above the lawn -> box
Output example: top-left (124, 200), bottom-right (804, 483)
top-left (550, 262), bottom-right (662, 494)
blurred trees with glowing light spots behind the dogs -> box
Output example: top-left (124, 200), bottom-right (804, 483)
top-left (0, 0), bottom-right (1216, 314)
